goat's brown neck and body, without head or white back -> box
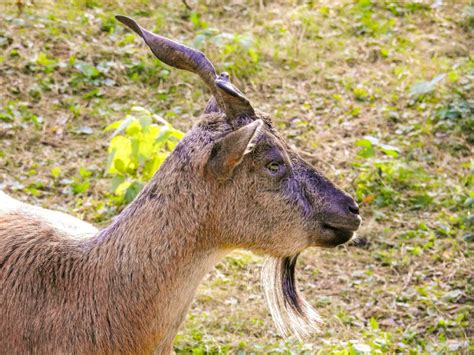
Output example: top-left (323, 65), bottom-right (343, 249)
top-left (0, 162), bottom-right (229, 354)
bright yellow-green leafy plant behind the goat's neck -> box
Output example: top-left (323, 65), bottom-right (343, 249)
top-left (105, 106), bottom-right (184, 203)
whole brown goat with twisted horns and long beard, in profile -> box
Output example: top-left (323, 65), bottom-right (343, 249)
top-left (0, 16), bottom-right (361, 354)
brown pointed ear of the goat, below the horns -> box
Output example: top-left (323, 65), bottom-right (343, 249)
top-left (206, 119), bottom-right (263, 180)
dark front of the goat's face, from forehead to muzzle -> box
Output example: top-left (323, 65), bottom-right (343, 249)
top-left (242, 127), bottom-right (361, 247)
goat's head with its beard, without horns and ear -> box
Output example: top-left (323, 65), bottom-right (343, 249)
top-left (156, 113), bottom-right (360, 336)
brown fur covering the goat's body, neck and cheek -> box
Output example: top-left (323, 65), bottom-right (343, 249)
top-left (0, 114), bottom-right (360, 354)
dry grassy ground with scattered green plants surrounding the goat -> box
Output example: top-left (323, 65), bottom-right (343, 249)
top-left (0, 0), bottom-right (474, 354)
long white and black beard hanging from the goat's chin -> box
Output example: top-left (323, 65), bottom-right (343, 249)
top-left (261, 254), bottom-right (321, 340)
